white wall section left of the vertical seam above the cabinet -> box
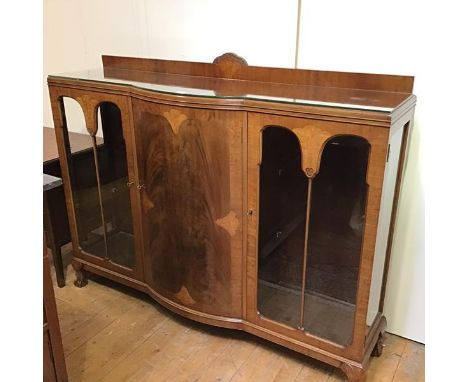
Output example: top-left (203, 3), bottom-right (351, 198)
top-left (44, 0), bottom-right (297, 126)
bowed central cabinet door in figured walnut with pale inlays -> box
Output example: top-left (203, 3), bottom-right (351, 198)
top-left (133, 100), bottom-right (243, 318)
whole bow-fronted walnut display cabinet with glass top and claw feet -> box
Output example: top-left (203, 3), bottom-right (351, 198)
top-left (48, 54), bottom-right (416, 381)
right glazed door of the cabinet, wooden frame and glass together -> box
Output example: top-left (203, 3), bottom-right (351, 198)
top-left (247, 113), bottom-right (388, 359)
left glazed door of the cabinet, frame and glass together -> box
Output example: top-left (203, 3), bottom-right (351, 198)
top-left (51, 89), bottom-right (142, 279)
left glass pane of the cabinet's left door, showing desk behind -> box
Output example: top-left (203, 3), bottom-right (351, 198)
top-left (62, 97), bottom-right (104, 257)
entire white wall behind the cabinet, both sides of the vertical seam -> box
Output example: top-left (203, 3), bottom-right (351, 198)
top-left (44, 0), bottom-right (424, 342)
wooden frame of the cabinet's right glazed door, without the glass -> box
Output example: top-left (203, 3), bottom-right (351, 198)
top-left (246, 113), bottom-right (389, 362)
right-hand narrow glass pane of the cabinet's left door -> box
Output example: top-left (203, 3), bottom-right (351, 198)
top-left (96, 103), bottom-right (135, 268)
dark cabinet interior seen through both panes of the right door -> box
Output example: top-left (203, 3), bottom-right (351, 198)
top-left (257, 126), bottom-right (369, 345)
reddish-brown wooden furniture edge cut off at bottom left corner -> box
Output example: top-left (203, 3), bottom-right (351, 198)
top-left (43, 237), bottom-right (68, 382)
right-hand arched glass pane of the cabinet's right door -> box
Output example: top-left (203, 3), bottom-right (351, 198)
top-left (304, 136), bottom-right (369, 345)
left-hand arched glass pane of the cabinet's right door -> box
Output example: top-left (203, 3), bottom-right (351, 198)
top-left (257, 126), bottom-right (307, 327)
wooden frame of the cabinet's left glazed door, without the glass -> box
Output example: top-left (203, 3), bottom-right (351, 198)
top-left (49, 85), bottom-right (143, 280)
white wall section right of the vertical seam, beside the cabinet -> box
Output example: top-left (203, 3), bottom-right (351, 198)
top-left (298, 0), bottom-right (426, 342)
